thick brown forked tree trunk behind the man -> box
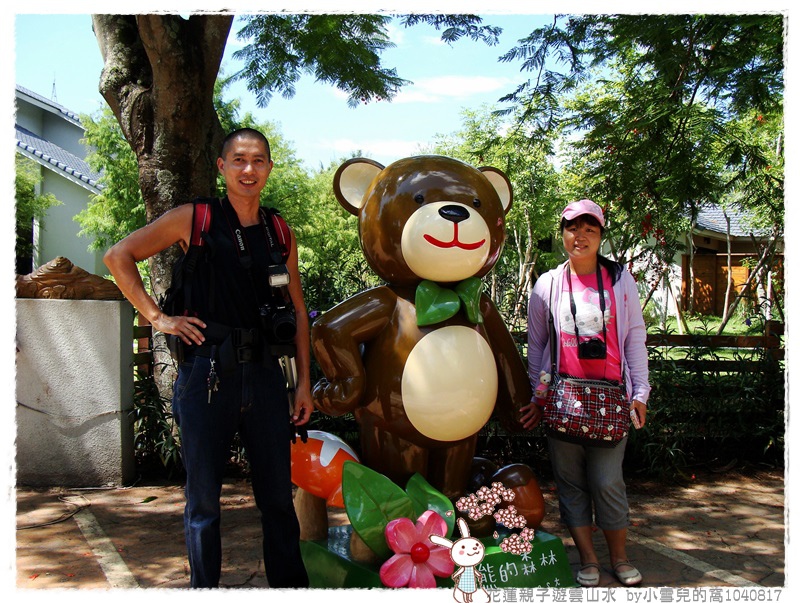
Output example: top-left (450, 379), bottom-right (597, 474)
top-left (92, 14), bottom-right (233, 395)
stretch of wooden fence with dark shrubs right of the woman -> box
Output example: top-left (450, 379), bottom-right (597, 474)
top-left (640, 324), bottom-right (786, 472)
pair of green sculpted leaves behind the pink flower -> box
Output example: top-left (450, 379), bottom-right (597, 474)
top-left (342, 461), bottom-right (455, 559)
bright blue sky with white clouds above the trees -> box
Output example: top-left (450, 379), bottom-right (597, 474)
top-left (14, 14), bottom-right (552, 168)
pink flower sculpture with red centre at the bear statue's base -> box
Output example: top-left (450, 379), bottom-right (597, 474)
top-left (380, 511), bottom-right (455, 588)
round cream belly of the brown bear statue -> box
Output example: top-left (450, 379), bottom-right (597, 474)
top-left (402, 326), bottom-right (497, 442)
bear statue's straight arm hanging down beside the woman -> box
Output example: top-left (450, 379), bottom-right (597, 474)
top-left (481, 295), bottom-right (531, 432)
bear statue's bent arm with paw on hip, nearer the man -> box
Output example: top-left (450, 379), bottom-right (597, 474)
top-left (311, 287), bottom-right (397, 416)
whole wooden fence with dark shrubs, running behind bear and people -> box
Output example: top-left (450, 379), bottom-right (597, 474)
top-left (128, 324), bottom-right (784, 474)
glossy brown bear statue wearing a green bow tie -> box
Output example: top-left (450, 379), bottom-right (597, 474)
top-left (312, 156), bottom-right (531, 497)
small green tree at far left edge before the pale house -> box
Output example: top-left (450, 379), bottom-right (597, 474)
top-left (14, 154), bottom-right (61, 274)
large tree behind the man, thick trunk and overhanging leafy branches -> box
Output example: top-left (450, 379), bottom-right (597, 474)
top-left (92, 14), bottom-right (497, 302)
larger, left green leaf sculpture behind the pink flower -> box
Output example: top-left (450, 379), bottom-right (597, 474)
top-left (342, 461), bottom-right (417, 559)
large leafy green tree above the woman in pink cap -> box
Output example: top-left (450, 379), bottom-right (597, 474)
top-left (502, 15), bottom-right (784, 320)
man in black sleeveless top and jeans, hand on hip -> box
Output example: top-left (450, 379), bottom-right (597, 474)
top-left (104, 129), bottom-right (313, 588)
